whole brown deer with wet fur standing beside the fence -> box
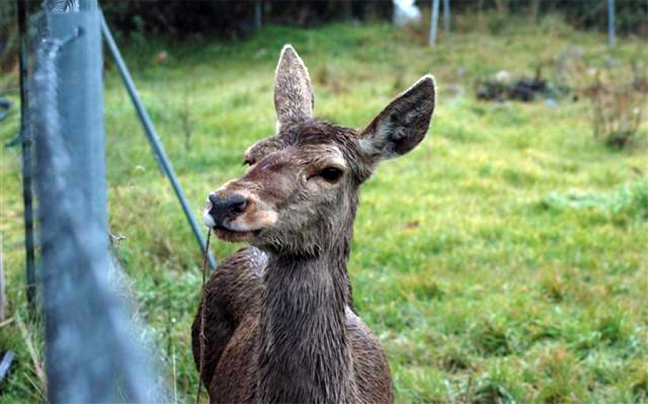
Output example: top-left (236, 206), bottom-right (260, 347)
top-left (192, 45), bottom-right (436, 403)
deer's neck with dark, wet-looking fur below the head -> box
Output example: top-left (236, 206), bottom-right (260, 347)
top-left (258, 248), bottom-right (355, 402)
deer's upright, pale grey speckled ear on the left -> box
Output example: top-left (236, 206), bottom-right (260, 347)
top-left (274, 45), bottom-right (314, 128)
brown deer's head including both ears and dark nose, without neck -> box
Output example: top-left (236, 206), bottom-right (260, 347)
top-left (203, 45), bottom-right (436, 256)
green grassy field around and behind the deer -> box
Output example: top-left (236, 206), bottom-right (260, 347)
top-left (0, 14), bottom-right (648, 403)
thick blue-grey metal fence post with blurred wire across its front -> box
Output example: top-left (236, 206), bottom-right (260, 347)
top-left (32, 0), bottom-right (164, 403)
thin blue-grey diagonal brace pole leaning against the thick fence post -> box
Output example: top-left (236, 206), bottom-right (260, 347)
top-left (101, 13), bottom-right (217, 269)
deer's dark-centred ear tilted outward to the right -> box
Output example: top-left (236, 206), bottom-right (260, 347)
top-left (360, 74), bottom-right (436, 161)
